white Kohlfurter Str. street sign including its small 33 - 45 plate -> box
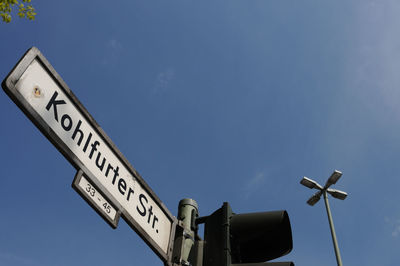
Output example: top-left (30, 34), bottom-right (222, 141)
top-left (2, 47), bottom-right (177, 264)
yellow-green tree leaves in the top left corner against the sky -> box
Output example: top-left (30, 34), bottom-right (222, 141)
top-left (0, 0), bottom-right (36, 23)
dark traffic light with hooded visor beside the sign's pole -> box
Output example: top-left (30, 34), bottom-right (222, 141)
top-left (202, 202), bottom-right (294, 266)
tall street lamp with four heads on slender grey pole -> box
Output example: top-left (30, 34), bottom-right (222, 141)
top-left (300, 170), bottom-right (347, 266)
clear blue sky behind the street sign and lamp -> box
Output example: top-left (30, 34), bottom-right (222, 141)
top-left (0, 0), bottom-right (400, 266)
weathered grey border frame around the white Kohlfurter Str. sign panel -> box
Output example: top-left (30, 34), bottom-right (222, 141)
top-left (1, 47), bottom-right (178, 265)
